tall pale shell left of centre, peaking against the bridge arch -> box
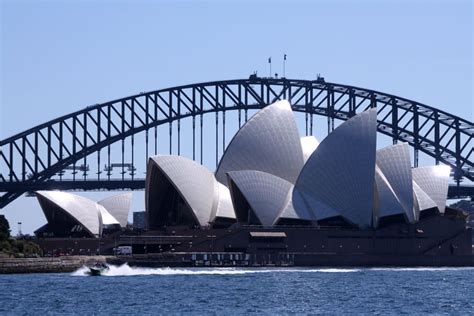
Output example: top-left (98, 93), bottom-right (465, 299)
top-left (216, 100), bottom-right (304, 185)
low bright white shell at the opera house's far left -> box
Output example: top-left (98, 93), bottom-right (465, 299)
top-left (36, 191), bottom-right (102, 236)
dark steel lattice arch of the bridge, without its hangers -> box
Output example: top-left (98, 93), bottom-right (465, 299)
top-left (0, 76), bottom-right (474, 208)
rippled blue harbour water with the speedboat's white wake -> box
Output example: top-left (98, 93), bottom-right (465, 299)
top-left (0, 265), bottom-right (474, 315)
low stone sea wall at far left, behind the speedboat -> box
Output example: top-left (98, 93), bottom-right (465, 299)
top-left (0, 256), bottom-right (107, 274)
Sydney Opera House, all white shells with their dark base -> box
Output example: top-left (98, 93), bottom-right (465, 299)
top-left (37, 101), bottom-right (472, 265)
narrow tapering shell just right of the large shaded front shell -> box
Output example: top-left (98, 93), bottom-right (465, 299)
top-left (377, 143), bottom-right (415, 223)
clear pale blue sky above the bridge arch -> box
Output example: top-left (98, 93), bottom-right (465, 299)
top-left (0, 0), bottom-right (474, 233)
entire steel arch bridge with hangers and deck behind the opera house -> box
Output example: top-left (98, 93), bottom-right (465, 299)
top-left (0, 75), bottom-right (474, 208)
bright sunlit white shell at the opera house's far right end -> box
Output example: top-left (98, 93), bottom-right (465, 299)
top-left (412, 165), bottom-right (451, 213)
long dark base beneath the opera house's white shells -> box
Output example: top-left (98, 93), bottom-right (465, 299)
top-left (37, 210), bottom-right (474, 266)
